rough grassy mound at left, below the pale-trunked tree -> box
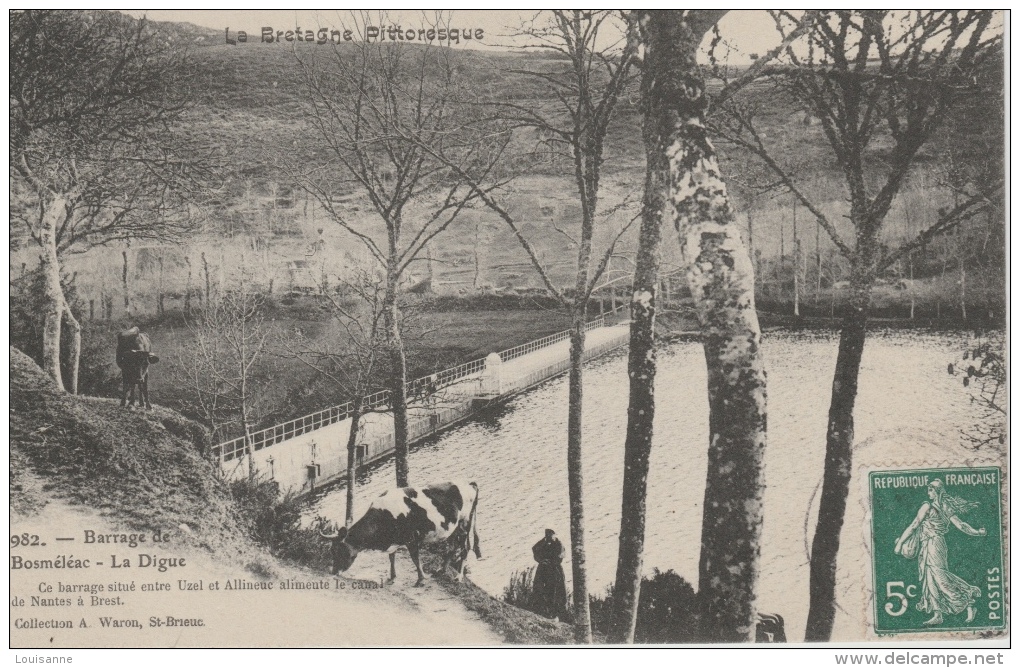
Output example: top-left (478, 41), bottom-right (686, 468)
top-left (9, 348), bottom-right (250, 559)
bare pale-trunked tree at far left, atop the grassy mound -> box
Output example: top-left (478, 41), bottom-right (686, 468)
top-left (9, 10), bottom-right (193, 394)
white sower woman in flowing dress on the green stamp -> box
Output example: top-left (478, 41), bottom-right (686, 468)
top-left (896, 480), bottom-right (987, 626)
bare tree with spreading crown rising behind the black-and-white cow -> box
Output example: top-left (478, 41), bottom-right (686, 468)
top-left (297, 16), bottom-right (499, 486)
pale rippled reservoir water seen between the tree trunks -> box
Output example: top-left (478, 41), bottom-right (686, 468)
top-left (307, 330), bottom-right (999, 640)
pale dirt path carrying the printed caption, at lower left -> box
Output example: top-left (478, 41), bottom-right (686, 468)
top-left (10, 502), bottom-right (502, 648)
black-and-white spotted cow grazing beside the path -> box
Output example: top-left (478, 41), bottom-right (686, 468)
top-left (319, 482), bottom-right (481, 586)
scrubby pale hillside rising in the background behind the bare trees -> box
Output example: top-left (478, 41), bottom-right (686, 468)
top-left (19, 20), bottom-right (1003, 312)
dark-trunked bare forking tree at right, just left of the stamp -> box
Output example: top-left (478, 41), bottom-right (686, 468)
top-left (722, 10), bottom-right (1002, 641)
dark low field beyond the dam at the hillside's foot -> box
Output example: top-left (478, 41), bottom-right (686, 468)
top-left (25, 259), bottom-right (1003, 446)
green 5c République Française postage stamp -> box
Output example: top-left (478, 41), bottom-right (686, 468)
top-left (868, 466), bottom-right (1006, 633)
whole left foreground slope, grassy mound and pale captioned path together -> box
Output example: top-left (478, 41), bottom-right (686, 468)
top-left (9, 349), bottom-right (569, 648)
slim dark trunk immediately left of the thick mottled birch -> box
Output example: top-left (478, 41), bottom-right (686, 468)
top-left (609, 96), bottom-right (665, 644)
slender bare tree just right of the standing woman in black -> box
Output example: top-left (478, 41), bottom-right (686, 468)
top-left (418, 10), bottom-right (636, 643)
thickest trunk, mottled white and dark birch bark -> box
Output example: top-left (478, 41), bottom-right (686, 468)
top-left (642, 11), bottom-right (766, 643)
